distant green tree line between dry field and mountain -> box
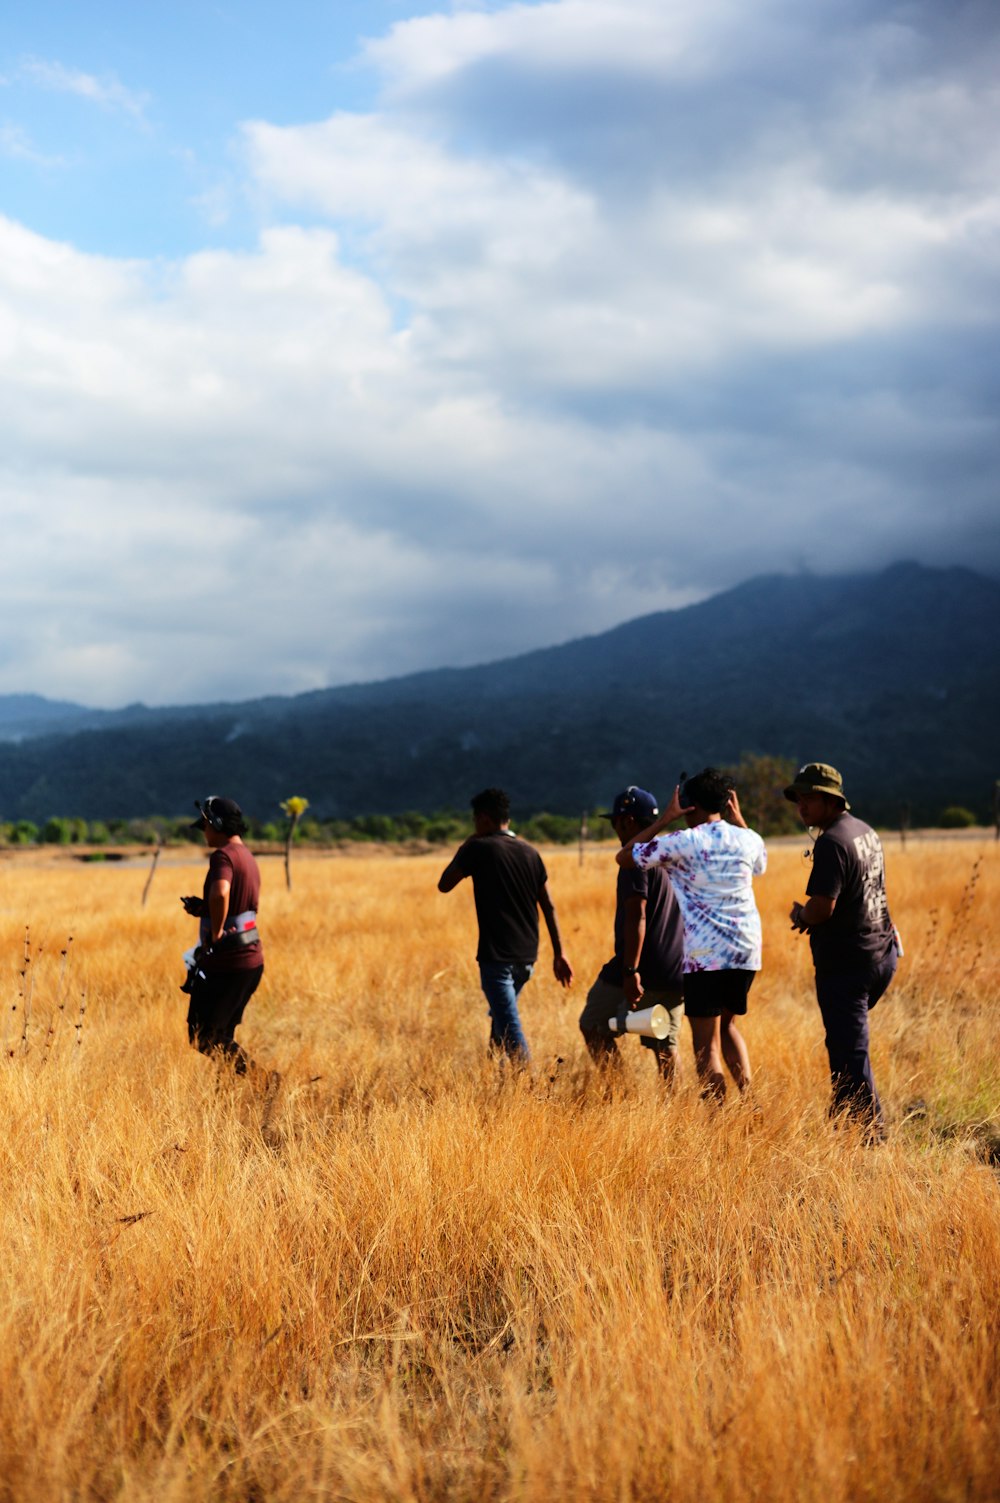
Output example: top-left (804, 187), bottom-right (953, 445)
top-left (0, 755), bottom-right (980, 846)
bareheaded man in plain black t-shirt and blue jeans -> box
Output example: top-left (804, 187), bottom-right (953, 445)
top-left (438, 788), bottom-right (573, 1061)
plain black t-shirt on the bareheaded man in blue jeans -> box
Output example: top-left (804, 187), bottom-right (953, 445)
top-left (456, 830), bottom-right (546, 965)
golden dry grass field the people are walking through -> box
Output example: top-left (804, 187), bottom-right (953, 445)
top-left (0, 837), bottom-right (1000, 1503)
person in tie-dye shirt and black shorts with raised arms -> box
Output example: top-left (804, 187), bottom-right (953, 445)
top-left (615, 767), bottom-right (767, 1099)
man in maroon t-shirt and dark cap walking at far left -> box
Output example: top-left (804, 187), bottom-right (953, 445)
top-left (180, 794), bottom-right (267, 1084)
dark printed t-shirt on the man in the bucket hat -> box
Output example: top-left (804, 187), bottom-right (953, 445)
top-left (806, 813), bottom-right (895, 975)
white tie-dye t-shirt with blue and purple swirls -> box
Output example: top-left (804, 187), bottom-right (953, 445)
top-left (632, 819), bottom-right (767, 975)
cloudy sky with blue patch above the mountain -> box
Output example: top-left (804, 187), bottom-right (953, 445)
top-left (0, 0), bottom-right (1000, 706)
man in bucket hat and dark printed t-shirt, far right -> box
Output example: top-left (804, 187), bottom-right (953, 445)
top-left (785, 762), bottom-right (898, 1138)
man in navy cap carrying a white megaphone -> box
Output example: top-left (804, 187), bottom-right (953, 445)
top-left (580, 785), bottom-right (684, 1087)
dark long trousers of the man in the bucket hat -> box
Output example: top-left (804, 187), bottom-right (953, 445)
top-left (817, 948), bottom-right (896, 1135)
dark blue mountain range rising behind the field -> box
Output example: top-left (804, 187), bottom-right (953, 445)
top-left (0, 564), bottom-right (1000, 821)
